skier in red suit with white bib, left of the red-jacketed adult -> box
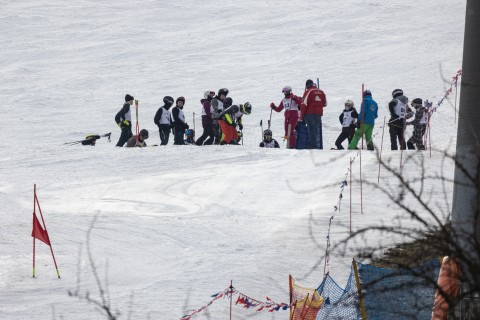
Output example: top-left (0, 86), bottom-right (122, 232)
top-left (270, 86), bottom-right (302, 149)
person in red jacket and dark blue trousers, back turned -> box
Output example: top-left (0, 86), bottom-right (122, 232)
top-left (300, 79), bottom-right (327, 149)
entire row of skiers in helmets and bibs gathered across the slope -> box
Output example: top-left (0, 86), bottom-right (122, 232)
top-left (109, 79), bottom-right (431, 150)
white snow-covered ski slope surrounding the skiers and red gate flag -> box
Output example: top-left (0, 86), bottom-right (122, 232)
top-left (0, 0), bottom-right (465, 319)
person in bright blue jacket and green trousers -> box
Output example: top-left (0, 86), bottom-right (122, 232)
top-left (348, 90), bottom-right (378, 150)
